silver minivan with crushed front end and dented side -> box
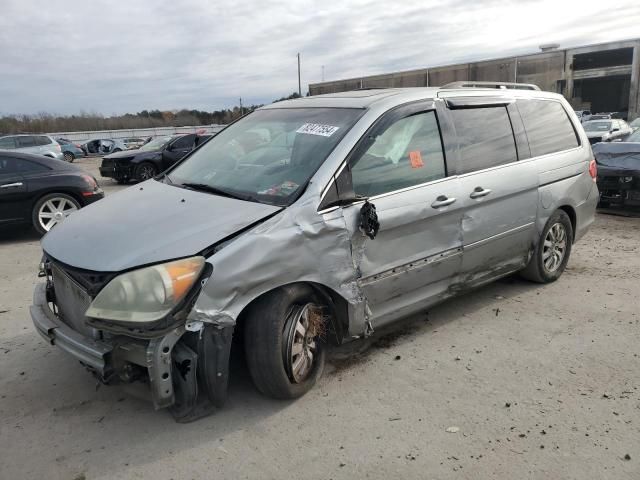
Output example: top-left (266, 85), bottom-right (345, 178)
top-left (31, 88), bottom-right (598, 421)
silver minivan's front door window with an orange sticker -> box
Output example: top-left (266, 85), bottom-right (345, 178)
top-left (351, 111), bottom-right (446, 197)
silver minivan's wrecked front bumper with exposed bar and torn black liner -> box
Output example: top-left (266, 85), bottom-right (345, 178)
top-left (30, 283), bottom-right (234, 422)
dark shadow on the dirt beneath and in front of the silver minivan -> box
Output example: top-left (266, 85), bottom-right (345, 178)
top-left (0, 277), bottom-right (542, 476)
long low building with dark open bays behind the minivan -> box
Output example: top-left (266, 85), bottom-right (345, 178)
top-left (309, 39), bottom-right (640, 120)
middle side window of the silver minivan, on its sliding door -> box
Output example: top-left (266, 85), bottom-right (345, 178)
top-left (451, 106), bottom-right (518, 173)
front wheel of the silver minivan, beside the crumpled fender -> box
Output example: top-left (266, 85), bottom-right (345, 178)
top-left (244, 285), bottom-right (326, 399)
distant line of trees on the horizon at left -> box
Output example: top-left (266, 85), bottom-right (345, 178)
top-left (0, 92), bottom-right (300, 134)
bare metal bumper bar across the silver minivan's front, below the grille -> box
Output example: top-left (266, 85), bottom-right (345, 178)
top-left (30, 283), bottom-right (113, 378)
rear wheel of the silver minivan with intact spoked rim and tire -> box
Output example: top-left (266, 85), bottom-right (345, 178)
top-left (520, 210), bottom-right (573, 283)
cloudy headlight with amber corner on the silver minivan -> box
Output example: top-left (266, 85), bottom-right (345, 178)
top-left (85, 257), bottom-right (204, 323)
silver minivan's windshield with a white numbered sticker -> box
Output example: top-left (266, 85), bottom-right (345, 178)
top-left (169, 108), bottom-right (363, 206)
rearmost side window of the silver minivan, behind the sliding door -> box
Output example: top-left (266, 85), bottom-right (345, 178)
top-left (516, 100), bottom-right (579, 157)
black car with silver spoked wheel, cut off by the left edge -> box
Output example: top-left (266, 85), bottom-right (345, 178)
top-left (0, 151), bottom-right (104, 234)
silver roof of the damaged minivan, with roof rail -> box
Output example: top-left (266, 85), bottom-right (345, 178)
top-left (260, 87), bottom-right (561, 110)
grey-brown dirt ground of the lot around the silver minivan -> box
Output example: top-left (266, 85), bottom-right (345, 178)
top-left (0, 160), bottom-right (640, 480)
